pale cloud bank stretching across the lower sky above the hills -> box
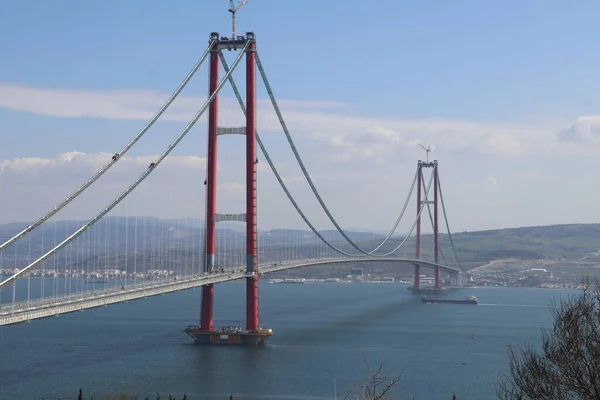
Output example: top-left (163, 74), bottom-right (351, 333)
top-left (0, 83), bottom-right (600, 230)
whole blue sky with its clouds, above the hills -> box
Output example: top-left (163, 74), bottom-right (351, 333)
top-left (0, 0), bottom-right (600, 229)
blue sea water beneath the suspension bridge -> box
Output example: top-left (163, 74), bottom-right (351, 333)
top-left (0, 282), bottom-right (573, 400)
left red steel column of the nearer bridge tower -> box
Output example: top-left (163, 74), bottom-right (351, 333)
top-left (200, 38), bottom-right (219, 331)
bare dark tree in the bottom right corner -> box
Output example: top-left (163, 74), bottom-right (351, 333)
top-left (496, 282), bottom-right (600, 400)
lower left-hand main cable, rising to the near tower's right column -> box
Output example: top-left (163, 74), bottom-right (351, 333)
top-left (0, 40), bottom-right (251, 288)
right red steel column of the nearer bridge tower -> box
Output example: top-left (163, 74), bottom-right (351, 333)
top-left (246, 39), bottom-right (258, 331)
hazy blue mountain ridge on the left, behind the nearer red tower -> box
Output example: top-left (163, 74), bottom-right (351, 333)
top-left (0, 217), bottom-right (390, 268)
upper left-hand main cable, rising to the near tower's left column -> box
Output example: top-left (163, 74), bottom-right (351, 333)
top-left (0, 41), bottom-right (215, 252)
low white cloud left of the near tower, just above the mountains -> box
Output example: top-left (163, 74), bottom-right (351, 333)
top-left (0, 151), bottom-right (210, 222)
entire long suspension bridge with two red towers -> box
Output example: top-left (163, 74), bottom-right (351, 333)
top-left (0, 32), bottom-right (466, 344)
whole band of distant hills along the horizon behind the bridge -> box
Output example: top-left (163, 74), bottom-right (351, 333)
top-left (0, 217), bottom-right (600, 268)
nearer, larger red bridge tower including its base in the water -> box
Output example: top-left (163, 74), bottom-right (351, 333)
top-left (185, 32), bottom-right (273, 345)
